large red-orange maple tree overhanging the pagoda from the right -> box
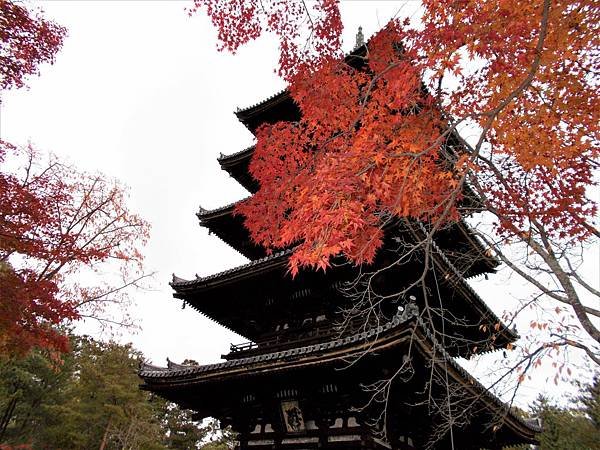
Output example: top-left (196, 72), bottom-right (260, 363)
top-left (191, 0), bottom-right (600, 372)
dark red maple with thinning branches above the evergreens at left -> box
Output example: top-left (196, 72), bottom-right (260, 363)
top-left (0, 141), bottom-right (148, 354)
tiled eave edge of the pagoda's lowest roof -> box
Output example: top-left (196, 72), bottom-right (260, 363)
top-left (139, 307), bottom-right (540, 443)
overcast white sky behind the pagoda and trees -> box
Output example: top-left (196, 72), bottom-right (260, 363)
top-left (0, 1), bottom-right (596, 408)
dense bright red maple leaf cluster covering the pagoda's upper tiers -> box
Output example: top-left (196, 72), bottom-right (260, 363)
top-left (237, 24), bottom-right (457, 274)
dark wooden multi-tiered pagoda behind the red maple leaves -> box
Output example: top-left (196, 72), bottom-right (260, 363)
top-left (140, 52), bottom-right (539, 450)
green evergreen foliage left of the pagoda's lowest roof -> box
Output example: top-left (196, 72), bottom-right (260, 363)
top-left (0, 336), bottom-right (233, 450)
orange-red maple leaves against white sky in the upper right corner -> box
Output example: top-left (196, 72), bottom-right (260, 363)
top-left (418, 0), bottom-right (600, 240)
